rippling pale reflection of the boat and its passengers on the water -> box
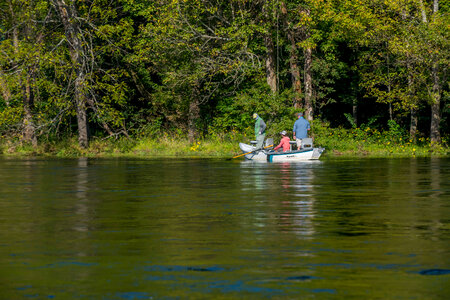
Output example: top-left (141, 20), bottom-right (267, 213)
top-left (237, 161), bottom-right (320, 238)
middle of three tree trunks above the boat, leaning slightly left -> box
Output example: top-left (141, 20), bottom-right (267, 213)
top-left (281, 2), bottom-right (303, 109)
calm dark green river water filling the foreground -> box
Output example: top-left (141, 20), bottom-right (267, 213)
top-left (0, 158), bottom-right (450, 299)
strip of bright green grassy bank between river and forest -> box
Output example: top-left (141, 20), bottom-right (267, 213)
top-left (0, 126), bottom-right (449, 159)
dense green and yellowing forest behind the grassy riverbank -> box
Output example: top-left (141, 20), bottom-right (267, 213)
top-left (0, 0), bottom-right (450, 148)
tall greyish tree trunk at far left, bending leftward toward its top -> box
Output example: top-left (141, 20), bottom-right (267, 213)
top-left (53, 0), bottom-right (89, 148)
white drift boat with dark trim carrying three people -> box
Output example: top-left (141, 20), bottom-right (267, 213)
top-left (239, 138), bottom-right (325, 162)
